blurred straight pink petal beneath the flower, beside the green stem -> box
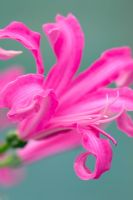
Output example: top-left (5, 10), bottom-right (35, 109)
top-left (18, 131), bottom-right (81, 164)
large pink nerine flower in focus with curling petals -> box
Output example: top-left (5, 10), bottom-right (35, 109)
top-left (0, 14), bottom-right (133, 183)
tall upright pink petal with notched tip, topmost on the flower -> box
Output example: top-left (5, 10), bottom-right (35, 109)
top-left (43, 14), bottom-right (84, 94)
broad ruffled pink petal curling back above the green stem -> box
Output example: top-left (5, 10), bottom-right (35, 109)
top-left (0, 74), bottom-right (58, 139)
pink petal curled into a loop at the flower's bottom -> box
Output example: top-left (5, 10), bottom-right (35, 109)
top-left (74, 130), bottom-right (112, 180)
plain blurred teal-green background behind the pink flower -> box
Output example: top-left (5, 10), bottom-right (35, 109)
top-left (0, 0), bottom-right (133, 200)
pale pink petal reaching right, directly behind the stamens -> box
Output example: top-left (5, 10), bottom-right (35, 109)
top-left (56, 87), bottom-right (133, 117)
